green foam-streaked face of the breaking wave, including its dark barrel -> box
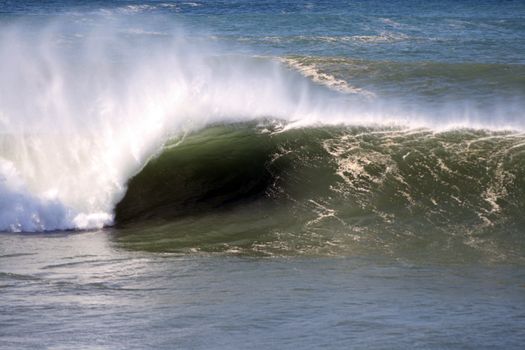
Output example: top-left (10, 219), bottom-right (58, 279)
top-left (114, 123), bottom-right (525, 261)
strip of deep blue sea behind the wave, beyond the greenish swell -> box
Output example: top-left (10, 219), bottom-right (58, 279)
top-left (0, 0), bottom-right (525, 64)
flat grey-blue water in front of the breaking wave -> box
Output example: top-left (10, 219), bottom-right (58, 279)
top-left (0, 232), bottom-right (525, 349)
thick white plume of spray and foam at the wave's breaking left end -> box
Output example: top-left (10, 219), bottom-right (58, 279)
top-left (0, 15), bottom-right (328, 231)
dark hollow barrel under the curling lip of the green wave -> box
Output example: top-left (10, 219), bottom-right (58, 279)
top-left (115, 127), bottom-right (274, 226)
